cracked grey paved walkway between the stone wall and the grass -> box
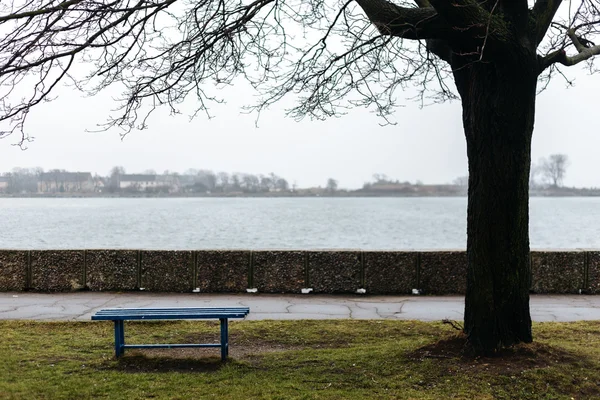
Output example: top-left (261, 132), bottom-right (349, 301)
top-left (0, 292), bottom-right (600, 321)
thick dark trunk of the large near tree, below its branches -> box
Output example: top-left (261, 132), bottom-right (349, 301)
top-left (453, 52), bottom-right (538, 354)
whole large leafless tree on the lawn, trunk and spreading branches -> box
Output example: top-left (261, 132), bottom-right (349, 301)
top-left (0, 0), bottom-right (600, 353)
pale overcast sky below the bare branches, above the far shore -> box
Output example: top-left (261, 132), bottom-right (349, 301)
top-left (0, 61), bottom-right (600, 188)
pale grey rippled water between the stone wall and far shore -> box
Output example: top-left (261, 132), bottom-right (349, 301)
top-left (0, 198), bottom-right (600, 250)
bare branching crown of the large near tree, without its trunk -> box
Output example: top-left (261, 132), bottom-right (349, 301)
top-left (0, 0), bottom-right (600, 144)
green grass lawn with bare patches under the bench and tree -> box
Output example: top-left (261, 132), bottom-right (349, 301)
top-left (0, 320), bottom-right (600, 400)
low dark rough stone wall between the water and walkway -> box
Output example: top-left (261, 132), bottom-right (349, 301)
top-left (0, 250), bottom-right (600, 295)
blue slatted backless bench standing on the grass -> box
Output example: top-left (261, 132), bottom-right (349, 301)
top-left (92, 307), bottom-right (250, 361)
